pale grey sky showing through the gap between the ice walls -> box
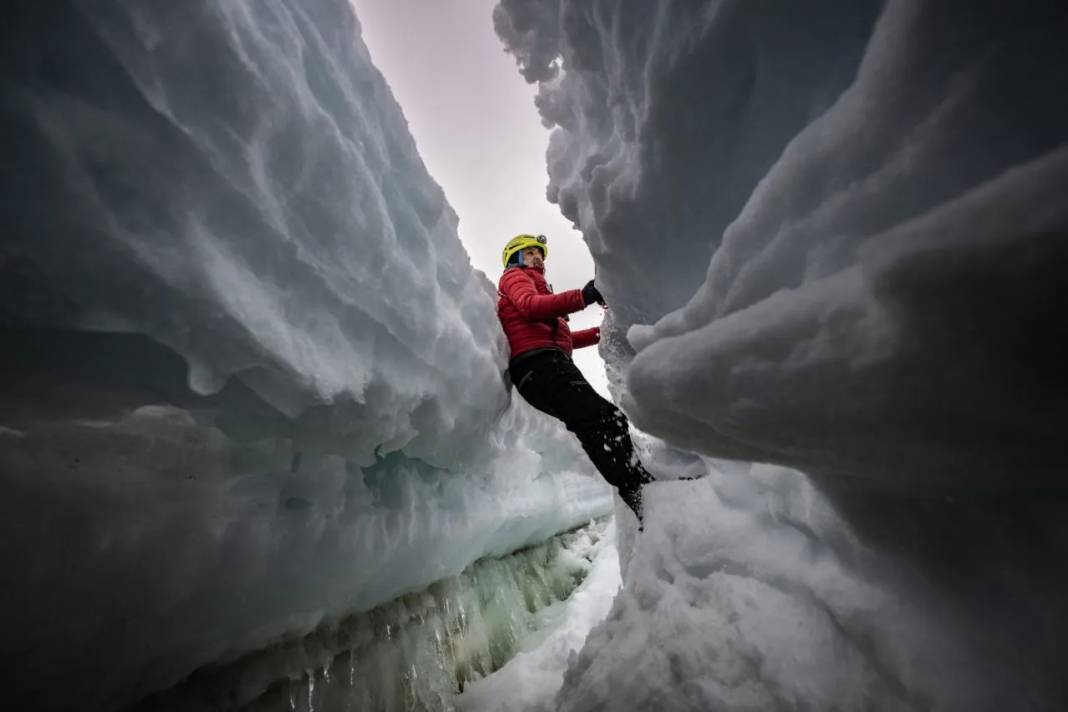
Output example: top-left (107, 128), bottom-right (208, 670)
top-left (352, 0), bottom-right (608, 396)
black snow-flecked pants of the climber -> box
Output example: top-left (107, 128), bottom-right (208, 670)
top-left (508, 349), bottom-right (653, 520)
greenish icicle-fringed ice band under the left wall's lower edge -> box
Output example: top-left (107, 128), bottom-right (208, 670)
top-left (135, 519), bottom-right (618, 712)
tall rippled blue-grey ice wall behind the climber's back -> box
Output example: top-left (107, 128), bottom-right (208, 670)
top-left (0, 0), bottom-right (611, 710)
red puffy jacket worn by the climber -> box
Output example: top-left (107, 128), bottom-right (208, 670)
top-left (497, 267), bottom-right (600, 359)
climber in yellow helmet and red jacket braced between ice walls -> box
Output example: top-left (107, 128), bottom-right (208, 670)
top-left (497, 235), bottom-right (653, 527)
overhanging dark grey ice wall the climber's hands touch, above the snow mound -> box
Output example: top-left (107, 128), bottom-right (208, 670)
top-left (497, 0), bottom-right (1068, 490)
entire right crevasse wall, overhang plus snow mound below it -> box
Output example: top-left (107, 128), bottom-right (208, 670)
top-left (494, 0), bottom-right (1068, 710)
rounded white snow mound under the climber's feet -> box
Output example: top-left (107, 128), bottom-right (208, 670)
top-left (553, 465), bottom-right (1003, 712)
